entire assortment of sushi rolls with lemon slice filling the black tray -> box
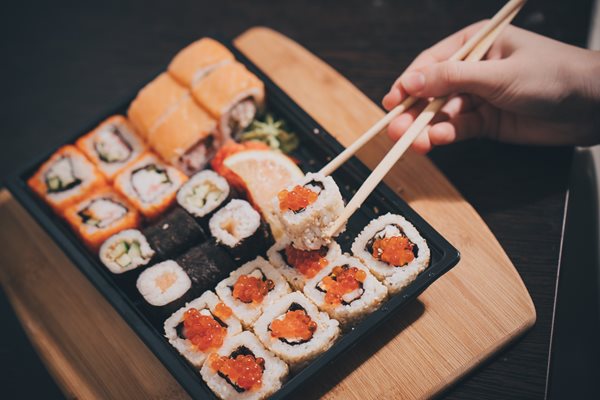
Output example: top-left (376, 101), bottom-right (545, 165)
top-left (28, 38), bottom-right (430, 399)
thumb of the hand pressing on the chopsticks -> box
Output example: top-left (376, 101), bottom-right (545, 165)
top-left (400, 60), bottom-right (510, 100)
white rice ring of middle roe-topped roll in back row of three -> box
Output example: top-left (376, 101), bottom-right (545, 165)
top-left (215, 257), bottom-right (290, 327)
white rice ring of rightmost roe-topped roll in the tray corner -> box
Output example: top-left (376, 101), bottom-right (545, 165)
top-left (352, 213), bottom-right (430, 293)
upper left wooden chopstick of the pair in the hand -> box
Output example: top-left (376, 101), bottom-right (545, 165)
top-left (319, 0), bottom-right (527, 175)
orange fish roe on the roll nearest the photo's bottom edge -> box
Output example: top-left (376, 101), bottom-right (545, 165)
top-left (210, 353), bottom-right (265, 390)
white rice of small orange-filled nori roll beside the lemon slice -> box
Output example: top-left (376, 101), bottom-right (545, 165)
top-left (208, 199), bottom-right (260, 248)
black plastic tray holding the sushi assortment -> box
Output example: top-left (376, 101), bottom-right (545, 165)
top-left (7, 38), bottom-right (460, 399)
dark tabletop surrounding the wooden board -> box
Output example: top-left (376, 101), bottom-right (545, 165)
top-left (0, 0), bottom-right (592, 399)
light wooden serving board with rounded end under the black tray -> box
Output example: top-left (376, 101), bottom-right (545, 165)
top-left (0, 28), bottom-right (535, 400)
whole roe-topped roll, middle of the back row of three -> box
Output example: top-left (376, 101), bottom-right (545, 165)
top-left (216, 257), bottom-right (290, 327)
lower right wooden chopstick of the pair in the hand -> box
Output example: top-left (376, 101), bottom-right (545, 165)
top-left (327, 0), bottom-right (525, 237)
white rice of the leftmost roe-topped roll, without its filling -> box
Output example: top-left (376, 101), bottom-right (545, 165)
top-left (164, 291), bottom-right (242, 368)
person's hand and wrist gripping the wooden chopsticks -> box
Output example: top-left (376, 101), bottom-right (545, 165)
top-left (383, 21), bottom-right (600, 153)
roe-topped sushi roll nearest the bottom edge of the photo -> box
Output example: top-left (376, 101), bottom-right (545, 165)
top-left (200, 332), bottom-right (288, 400)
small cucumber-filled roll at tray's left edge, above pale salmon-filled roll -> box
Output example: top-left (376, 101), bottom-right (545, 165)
top-left (99, 229), bottom-right (155, 274)
